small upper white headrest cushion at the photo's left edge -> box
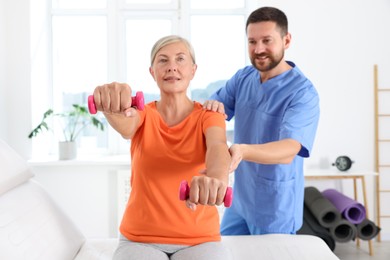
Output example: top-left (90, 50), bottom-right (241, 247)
top-left (0, 140), bottom-right (34, 195)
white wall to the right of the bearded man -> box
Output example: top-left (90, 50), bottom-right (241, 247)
top-left (261, 0), bottom-right (390, 169)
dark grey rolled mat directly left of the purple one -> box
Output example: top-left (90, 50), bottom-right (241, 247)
top-left (304, 187), bottom-right (341, 228)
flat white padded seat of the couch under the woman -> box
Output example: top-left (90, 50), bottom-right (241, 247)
top-left (75, 234), bottom-right (339, 260)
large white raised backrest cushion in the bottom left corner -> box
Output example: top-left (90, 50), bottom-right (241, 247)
top-left (0, 180), bottom-right (85, 260)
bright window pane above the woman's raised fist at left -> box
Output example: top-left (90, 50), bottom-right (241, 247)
top-left (53, 16), bottom-right (107, 97)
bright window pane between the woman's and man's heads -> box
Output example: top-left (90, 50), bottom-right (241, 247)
top-left (191, 15), bottom-right (246, 94)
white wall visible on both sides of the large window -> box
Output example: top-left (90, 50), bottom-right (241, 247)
top-left (0, 0), bottom-right (390, 240)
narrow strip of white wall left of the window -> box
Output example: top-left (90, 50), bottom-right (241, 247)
top-left (0, 0), bottom-right (31, 158)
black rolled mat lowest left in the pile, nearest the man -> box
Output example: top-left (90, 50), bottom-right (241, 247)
top-left (297, 205), bottom-right (336, 251)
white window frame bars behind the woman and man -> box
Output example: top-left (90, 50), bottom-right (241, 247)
top-left (32, 0), bottom-right (254, 154)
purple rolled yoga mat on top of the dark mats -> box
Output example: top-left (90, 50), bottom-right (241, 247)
top-left (322, 189), bottom-right (366, 224)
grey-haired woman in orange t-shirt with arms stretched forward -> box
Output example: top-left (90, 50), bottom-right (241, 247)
top-left (94, 35), bottom-right (231, 260)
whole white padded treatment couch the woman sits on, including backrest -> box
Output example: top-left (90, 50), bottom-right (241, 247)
top-left (0, 140), bottom-right (339, 260)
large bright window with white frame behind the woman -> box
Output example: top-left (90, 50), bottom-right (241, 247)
top-left (32, 0), bottom-right (253, 154)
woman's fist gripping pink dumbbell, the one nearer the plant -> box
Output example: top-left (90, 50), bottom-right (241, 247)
top-left (93, 82), bottom-right (136, 117)
